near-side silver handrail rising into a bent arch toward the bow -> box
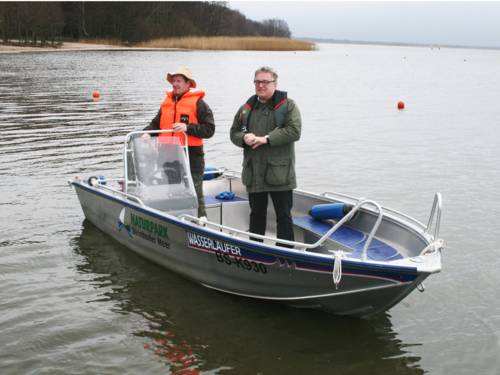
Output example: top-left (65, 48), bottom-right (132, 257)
top-left (179, 200), bottom-right (383, 260)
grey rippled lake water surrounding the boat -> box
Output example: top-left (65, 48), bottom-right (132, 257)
top-left (0, 44), bottom-right (500, 375)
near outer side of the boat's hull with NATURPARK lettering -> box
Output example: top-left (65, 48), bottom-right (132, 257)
top-left (72, 181), bottom-right (429, 317)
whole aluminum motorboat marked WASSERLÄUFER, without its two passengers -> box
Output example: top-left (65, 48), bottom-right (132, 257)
top-left (69, 131), bottom-right (443, 317)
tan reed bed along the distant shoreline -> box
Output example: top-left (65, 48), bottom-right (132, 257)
top-left (134, 36), bottom-right (316, 51)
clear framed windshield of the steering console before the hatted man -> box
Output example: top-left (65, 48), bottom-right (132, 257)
top-left (126, 133), bottom-right (198, 216)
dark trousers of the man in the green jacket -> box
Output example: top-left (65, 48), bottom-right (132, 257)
top-left (248, 190), bottom-right (294, 246)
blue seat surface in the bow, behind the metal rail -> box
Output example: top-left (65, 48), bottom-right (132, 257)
top-left (293, 215), bottom-right (403, 261)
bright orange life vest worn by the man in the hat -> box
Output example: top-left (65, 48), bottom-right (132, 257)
top-left (159, 89), bottom-right (205, 146)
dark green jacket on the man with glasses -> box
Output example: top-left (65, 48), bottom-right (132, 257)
top-left (230, 91), bottom-right (302, 193)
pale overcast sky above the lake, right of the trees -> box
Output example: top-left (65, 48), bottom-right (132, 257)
top-left (228, 1), bottom-right (500, 47)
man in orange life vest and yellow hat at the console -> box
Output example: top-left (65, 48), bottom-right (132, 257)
top-left (144, 67), bottom-right (215, 217)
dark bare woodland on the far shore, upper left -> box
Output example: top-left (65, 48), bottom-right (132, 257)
top-left (0, 1), bottom-right (291, 44)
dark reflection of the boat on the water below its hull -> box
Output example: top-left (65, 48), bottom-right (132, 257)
top-left (73, 221), bottom-right (424, 375)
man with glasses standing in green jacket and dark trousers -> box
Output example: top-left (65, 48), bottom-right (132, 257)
top-left (230, 67), bottom-right (302, 246)
